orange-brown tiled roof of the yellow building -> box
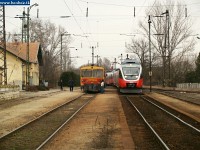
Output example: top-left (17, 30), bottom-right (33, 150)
top-left (6, 42), bottom-right (41, 63)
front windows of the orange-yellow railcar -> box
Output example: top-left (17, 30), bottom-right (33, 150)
top-left (81, 69), bottom-right (103, 77)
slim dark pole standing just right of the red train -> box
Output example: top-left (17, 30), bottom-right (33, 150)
top-left (148, 15), bottom-right (152, 92)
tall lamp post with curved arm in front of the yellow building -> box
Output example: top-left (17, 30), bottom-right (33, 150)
top-left (26, 3), bottom-right (39, 85)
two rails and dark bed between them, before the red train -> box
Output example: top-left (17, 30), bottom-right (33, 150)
top-left (126, 96), bottom-right (200, 150)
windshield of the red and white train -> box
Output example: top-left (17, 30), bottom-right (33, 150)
top-left (122, 67), bottom-right (140, 80)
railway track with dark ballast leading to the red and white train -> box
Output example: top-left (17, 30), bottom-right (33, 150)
top-left (123, 96), bottom-right (200, 149)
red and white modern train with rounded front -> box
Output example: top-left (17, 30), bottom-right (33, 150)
top-left (113, 59), bottom-right (143, 93)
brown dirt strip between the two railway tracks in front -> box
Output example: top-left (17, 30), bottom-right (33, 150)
top-left (45, 89), bottom-right (135, 150)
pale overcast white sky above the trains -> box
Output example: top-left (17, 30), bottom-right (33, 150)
top-left (5, 0), bottom-right (200, 67)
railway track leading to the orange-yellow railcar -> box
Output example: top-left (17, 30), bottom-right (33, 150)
top-left (0, 94), bottom-right (96, 150)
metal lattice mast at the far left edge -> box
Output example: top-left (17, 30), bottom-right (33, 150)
top-left (0, 5), bottom-right (7, 85)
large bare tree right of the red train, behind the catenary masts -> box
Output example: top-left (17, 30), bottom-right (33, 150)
top-left (140, 1), bottom-right (195, 85)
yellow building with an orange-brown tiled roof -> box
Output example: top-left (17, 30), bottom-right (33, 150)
top-left (0, 42), bottom-right (43, 89)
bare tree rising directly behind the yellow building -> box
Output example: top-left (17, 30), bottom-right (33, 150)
top-left (30, 19), bottom-right (70, 86)
